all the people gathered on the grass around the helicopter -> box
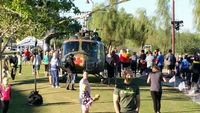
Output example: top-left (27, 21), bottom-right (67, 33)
top-left (0, 47), bottom-right (200, 113)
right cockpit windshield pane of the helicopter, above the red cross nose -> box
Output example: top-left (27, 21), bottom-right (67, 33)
top-left (82, 42), bottom-right (98, 57)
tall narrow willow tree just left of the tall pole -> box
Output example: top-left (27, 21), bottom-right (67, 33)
top-left (156, 0), bottom-right (171, 51)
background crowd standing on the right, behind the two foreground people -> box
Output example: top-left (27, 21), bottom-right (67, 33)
top-left (106, 48), bottom-right (200, 89)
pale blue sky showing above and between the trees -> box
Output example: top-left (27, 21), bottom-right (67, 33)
top-left (74, 0), bottom-right (196, 32)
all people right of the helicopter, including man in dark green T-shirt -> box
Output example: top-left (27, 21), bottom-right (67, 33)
top-left (106, 49), bottom-right (200, 113)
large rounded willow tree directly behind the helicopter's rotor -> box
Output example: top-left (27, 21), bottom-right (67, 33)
top-left (89, 5), bottom-right (134, 46)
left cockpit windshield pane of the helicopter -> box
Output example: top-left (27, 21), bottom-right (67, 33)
top-left (63, 41), bottom-right (79, 54)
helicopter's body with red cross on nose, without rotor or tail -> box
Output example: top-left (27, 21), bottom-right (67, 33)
top-left (61, 31), bottom-right (105, 78)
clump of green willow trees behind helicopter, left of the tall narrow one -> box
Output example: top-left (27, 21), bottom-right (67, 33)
top-left (89, 5), bottom-right (152, 46)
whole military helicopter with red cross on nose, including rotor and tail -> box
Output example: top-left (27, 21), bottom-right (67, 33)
top-left (44, 0), bottom-right (130, 79)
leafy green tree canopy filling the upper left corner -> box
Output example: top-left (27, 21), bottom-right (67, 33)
top-left (0, 0), bottom-right (80, 38)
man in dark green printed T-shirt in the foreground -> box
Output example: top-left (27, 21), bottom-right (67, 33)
top-left (113, 69), bottom-right (140, 113)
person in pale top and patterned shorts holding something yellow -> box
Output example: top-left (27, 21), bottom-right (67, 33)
top-left (79, 71), bottom-right (100, 113)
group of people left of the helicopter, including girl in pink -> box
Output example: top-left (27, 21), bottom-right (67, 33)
top-left (0, 49), bottom-right (60, 113)
